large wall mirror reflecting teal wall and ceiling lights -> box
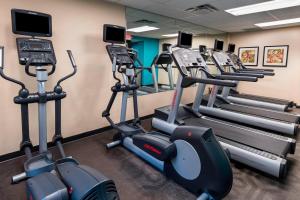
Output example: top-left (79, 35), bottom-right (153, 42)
top-left (126, 7), bottom-right (227, 95)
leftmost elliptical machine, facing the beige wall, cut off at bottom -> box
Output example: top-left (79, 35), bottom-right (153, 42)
top-left (0, 9), bottom-right (118, 200)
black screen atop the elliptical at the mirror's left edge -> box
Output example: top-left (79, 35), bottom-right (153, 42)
top-left (103, 24), bottom-right (126, 44)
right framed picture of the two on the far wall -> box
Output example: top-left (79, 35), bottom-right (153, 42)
top-left (263, 45), bottom-right (289, 67)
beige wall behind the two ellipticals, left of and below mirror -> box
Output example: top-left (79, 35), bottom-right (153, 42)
top-left (0, 0), bottom-right (197, 155)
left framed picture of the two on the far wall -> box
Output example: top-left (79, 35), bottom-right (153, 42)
top-left (239, 47), bottom-right (259, 66)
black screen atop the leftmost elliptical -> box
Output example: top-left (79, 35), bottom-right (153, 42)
top-left (11, 9), bottom-right (52, 37)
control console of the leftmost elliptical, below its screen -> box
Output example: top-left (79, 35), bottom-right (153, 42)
top-left (17, 38), bottom-right (56, 66)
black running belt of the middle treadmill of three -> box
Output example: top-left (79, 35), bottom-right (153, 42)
top-left (220, 104), bottom-right (300, 124)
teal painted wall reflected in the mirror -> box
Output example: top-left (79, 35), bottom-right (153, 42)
top-left (131, 36), bottom-right (159, 85)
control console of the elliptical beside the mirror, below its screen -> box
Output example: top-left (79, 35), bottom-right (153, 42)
top-left (106, 45), bottom-right (133, 65)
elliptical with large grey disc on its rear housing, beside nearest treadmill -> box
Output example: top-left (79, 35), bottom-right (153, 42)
top-left (102, 24), bottom-right (233, 200)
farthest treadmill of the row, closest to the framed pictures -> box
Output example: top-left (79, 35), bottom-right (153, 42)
top-left (228, 44), bottom-right (295, 111)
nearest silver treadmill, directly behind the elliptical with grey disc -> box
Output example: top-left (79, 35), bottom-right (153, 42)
top-left (152, 32), bottom-right (296, 179)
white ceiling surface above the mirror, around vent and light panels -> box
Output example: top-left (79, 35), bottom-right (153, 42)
top-left (107, 0), bottom-right (300, 33)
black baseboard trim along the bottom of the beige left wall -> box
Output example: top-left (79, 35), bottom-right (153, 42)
top-left (0, 114), bottom-right (153, 162)
